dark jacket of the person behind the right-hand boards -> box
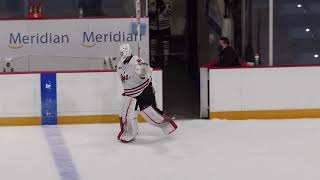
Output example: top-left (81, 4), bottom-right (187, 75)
top-left (218, 46), bottom-right (240, 67)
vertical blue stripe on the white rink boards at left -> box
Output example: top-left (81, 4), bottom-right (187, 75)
top-left (41, 74), bottom-right (58, 125)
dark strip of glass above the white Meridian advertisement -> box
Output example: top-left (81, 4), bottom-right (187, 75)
top-left (0, 0), bottom-right (146, 18)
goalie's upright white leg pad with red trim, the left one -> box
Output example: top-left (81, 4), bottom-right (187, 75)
top-left (118, 96), bottom-right (138, 142)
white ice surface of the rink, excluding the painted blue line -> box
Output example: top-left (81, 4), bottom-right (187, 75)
top-left (0, 120), bottom-right (320, 180)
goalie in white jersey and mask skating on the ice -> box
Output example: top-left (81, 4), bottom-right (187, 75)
top-left (117, 44), bottom-right (178, 143)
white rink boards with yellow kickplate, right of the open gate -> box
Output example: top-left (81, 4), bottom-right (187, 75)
top-left (200, 66), bottom-right (320, 120)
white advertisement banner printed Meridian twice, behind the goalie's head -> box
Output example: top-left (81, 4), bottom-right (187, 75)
top-left (0, 18), bottom-right (149, 62)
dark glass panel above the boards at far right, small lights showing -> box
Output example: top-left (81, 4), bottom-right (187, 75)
top-left (274, 0), bottom-right (320, 65)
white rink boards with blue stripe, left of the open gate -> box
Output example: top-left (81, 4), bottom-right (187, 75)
top-left (0, 71), bottom-right (163, 126)
